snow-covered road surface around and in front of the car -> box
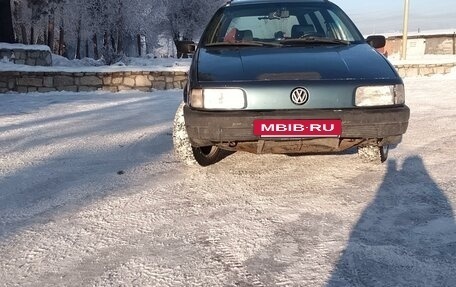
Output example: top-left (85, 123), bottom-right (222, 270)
top-left (0, 77), bottom-right (456, 287)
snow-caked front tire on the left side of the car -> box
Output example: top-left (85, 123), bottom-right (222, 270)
top-left (173, 103), bottom-right (233, 166)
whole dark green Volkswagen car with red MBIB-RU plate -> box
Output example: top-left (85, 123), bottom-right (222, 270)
top-left (173, 0), bottom-right (410, 166)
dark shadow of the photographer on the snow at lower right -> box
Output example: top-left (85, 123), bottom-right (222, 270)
top-left (326, 157), bottom-right (456, 287)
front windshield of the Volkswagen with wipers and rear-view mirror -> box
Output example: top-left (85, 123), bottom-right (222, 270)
top-left (202, 2), bottom-right (364, 46)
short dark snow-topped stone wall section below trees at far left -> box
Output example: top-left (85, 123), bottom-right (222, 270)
top-left (0, 45), bottom-right (52, 66)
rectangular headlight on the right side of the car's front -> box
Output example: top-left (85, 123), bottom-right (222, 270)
top-left (355, 84), bottom-right (405, 107)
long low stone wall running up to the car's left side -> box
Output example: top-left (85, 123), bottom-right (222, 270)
top-left (0, 72), bottom-right (187, 93)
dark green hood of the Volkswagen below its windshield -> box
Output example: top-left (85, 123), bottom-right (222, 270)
top-left (196, 44), bottom-right (398, 82)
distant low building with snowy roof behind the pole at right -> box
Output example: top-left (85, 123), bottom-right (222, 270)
top-left (384, 29), bottom-right (456, 56)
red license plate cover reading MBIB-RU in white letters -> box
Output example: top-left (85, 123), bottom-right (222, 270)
top-left (253, 119), bottom-right (342, 138)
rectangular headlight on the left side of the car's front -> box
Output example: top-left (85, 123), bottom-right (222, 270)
top-left (190, 89), bottom-right (246, 110)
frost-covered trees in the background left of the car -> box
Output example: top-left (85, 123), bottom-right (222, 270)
top-left (0, 0), bottom-right (223, 63)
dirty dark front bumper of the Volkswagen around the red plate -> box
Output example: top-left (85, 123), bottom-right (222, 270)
top-left (184, 106), bottom-right (410, 146)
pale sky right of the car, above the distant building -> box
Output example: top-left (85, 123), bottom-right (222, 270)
top-left (331, 0), bottom-right (456, 34)
